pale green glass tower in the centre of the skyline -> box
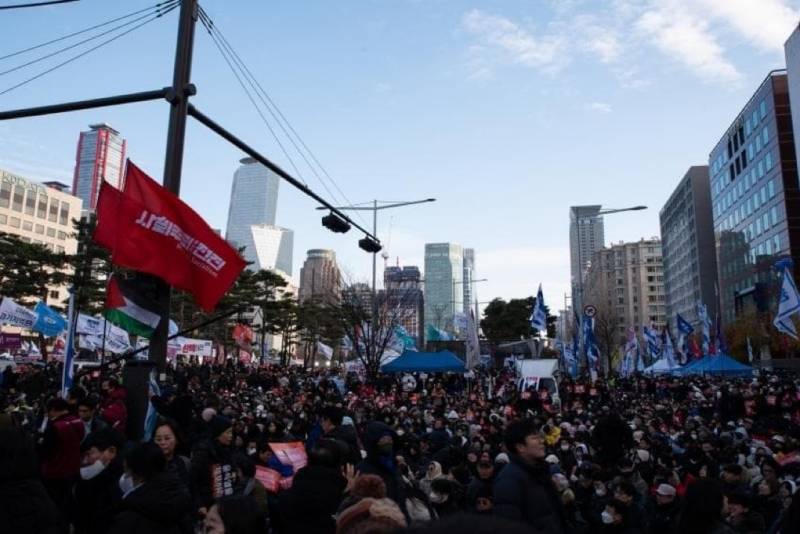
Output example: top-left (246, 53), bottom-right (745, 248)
top-left (425, 243), bottom-right (464, 331)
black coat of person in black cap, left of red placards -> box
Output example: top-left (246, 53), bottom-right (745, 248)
top-left (191, 439), bottom-right (236, 508)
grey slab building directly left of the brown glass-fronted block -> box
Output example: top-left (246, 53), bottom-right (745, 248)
top-left (659, 165), bottom-right (717, 331)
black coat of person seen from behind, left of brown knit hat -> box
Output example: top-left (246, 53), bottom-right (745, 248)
top-left (277, 465), bottom-right (347, 534)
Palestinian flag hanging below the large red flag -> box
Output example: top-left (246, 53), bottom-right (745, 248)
top-left (103, 275), bottom-right (161, 338)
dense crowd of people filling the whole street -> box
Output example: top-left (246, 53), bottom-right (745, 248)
top-left (0, 362), bottom-right (800, 534)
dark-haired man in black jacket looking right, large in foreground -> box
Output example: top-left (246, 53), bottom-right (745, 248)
top-left (494, 419), bottom-right (566, 534)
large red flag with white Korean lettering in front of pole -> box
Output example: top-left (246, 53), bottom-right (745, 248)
top-left (95, 165), bottom-right (245, 310)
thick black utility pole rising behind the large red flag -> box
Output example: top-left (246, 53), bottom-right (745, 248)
top-left (150, 0), bottom-right (197, 380)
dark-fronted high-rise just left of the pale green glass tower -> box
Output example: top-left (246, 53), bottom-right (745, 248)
top-left (379, 265), bottom-right (425, 349)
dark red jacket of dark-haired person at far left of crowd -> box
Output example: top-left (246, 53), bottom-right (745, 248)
top-left (42, 414), bottom-right (84, 479)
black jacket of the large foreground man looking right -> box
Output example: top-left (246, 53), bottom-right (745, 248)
top-left (494, 455), bottom-right (566, 534)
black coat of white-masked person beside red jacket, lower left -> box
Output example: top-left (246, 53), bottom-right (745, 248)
top-left (70, 457), bottom-right (123, 534)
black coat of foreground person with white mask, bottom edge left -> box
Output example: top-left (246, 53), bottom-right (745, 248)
top-left (108, 473), bottom-right (192, 534)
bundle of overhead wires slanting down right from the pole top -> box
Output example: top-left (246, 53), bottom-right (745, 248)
top-left (198, 6), bottom-right (367, 230)
